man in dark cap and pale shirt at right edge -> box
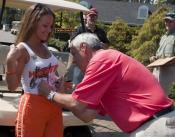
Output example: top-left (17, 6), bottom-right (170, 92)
top-left (150, 12), bottom-right (175, 95)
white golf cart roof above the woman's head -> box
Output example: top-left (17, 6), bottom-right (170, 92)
top-left (0, 0), bottom-right (89, 12)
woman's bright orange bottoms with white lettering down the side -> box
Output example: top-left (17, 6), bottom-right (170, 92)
top-left (16, 93), bottom-right (63, 137)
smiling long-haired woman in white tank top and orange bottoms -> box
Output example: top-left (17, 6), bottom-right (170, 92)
top-left (6, 4), bottom-right (63, 137)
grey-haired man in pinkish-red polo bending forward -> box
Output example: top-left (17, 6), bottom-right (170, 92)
top-left (39, 33), bottom-right (175, 137)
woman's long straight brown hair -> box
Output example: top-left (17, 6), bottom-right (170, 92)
top-left (15, 3), bottom-right (55, 45)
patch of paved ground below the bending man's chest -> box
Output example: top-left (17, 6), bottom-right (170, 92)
top-left (90, 116), bottom-right (129, 137)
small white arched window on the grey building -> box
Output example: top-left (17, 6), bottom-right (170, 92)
top-left (137, 6), bottom-right (148, 19)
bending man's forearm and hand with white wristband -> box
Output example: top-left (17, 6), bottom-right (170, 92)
top-left (38, 81), bottom-right (97, 122)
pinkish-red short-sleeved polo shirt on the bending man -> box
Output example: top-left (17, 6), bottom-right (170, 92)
top-left (72, 49), bottom-right (173, 132)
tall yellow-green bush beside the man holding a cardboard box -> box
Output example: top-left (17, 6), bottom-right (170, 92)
top-left (129, 6), bottom-right (169, 65)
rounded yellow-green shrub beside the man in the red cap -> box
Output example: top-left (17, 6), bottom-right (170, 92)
top-left (107, 19), bottom-right (137, 53)
